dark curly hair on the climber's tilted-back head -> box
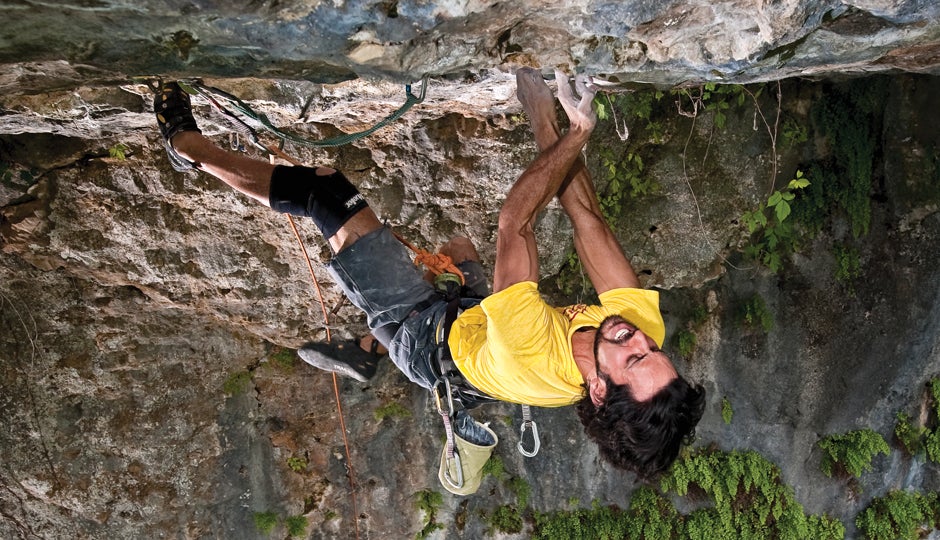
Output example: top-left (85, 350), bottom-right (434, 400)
top-left (577, 373), bottom-right (705, 481)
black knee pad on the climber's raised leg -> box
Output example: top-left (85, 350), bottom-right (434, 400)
top-left (268, 165), bottom-right (369, 238)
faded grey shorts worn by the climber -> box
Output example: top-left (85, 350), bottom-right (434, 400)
top-left (327, 227), bottom-right (489, 389)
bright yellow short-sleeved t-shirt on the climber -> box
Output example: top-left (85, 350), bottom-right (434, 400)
top-left (448, 281), bottom-right (666, 407)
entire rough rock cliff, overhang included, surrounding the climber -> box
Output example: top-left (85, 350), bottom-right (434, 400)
top-left (0, 1), bottom-right (940, 538)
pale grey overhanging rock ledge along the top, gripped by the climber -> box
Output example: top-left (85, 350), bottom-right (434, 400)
top-left (0, 0), bottom-right (940, 93)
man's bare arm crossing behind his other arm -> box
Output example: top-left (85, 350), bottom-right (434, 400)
top-left (516, 68), bottom-right (640, 294)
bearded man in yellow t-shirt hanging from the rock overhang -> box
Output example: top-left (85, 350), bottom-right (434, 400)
top-left (154, 69), bottom-right (704, 477)
